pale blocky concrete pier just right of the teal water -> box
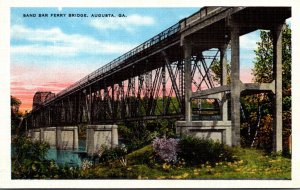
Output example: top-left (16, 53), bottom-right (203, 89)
top-left (86, 125), bottom-right (118, 155)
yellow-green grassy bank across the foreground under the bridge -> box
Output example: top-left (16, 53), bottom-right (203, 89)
top-left (82, 146), bottom-right (291, 179)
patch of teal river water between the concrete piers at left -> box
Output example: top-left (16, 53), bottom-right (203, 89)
top-left (46, 140), bottom-right (86, 167)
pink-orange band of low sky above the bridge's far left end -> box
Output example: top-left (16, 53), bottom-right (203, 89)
top-left (10, 64), bottom-right (85, 112)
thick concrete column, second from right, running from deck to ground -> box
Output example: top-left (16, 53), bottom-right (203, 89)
top-left (230, 20), bottom-right (241, 146)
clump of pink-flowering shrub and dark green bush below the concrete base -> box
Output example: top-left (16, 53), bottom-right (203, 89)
top-left (152, 136), bottom-right (235, 165)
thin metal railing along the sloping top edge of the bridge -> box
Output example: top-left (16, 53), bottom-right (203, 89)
top-left (44, 22), bottom-right (180, 104)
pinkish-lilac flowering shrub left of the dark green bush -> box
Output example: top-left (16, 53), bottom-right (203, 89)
top-left (152, 138), bottom-right (179, 163)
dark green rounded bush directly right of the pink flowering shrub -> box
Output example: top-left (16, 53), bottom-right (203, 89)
top-left (178, 136), bottom-right (234, 165)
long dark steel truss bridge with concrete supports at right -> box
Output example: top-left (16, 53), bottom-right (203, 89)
top-left (26, 7), bottom-right (291, 151)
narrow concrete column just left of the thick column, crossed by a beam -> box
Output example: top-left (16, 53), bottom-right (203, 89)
top-left (220, 44), bottom-right (228, 121)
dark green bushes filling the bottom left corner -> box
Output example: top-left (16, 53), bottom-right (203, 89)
top-left (12, 136), bottom-right (78, 179)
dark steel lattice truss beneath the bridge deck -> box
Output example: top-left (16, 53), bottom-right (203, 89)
top-left (33, 49), bottom-right (220, 127)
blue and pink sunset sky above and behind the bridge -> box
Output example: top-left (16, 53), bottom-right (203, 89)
top-left (10, 7), bottom-right (266, 111)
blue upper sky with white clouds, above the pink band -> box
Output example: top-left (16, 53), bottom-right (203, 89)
top-left (11, 8), bottom-right (199, 69)
